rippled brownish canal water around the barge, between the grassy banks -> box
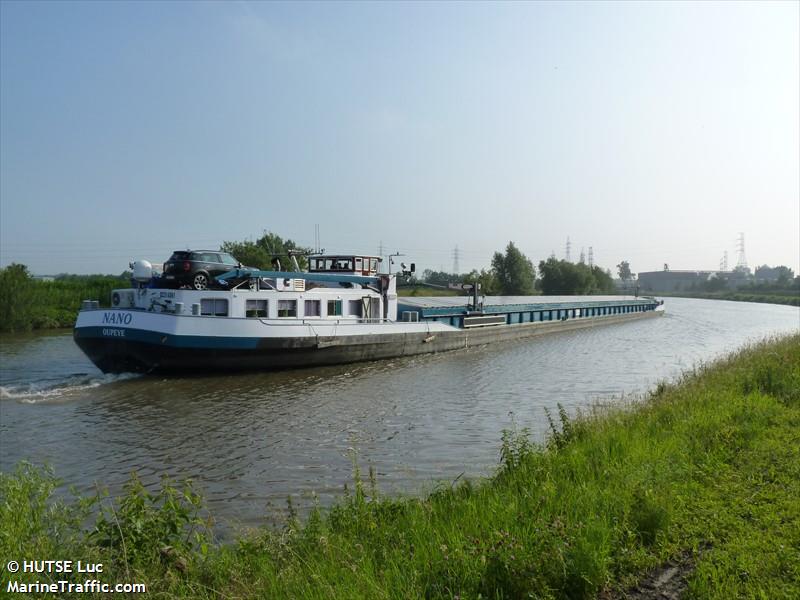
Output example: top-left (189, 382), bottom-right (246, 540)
top-left (0, 298), bottom-right (800, 526)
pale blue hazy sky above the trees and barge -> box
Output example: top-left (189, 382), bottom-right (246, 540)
top-left (0, 0), bottom-right (800, 274)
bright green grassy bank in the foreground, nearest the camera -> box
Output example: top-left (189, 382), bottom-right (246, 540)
top-left (0, 335), bottom-right (800, 599)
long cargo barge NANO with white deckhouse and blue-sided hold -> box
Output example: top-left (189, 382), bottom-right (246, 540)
top-left (74, 255), bottom-right (663, 373)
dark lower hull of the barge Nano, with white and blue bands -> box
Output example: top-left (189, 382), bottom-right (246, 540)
top-left (74, 310), bottom-right (663, 373)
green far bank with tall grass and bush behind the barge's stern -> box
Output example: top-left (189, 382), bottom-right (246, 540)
top-left (0, 264), bottom-right (129, 331)
